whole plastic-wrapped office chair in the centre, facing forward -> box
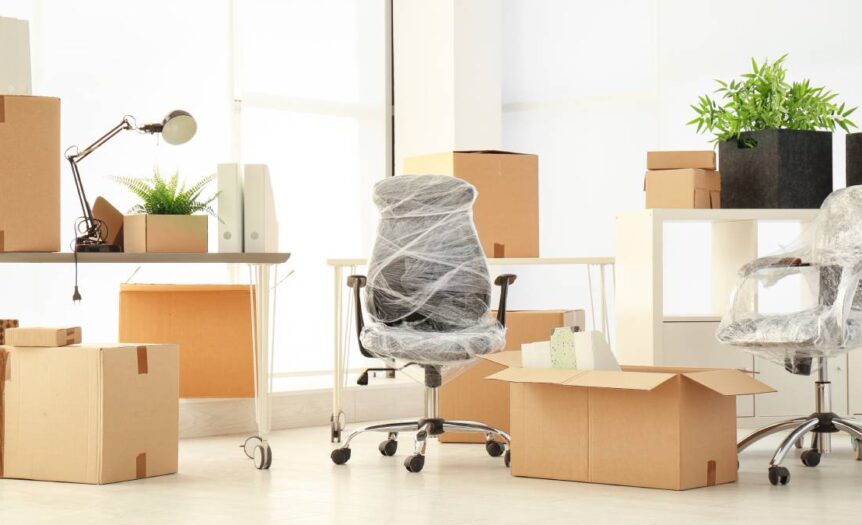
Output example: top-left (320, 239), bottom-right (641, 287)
top-left (331, 175), bottom-right (515, 472)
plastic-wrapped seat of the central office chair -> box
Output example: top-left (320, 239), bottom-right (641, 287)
top-left (360, 318), bottom-right (506, 365)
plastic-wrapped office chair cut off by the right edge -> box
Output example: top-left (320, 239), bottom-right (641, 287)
top-left (716, 186), bottom-right (862, 485)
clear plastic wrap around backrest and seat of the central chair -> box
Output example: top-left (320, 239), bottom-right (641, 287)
top-left (360, 175), bottom-right (505, 365)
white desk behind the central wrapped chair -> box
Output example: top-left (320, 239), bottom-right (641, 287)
top-left (326, 257), bottom-right (614, 443)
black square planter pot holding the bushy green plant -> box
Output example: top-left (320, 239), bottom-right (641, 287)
top-left (718, 129), bottom-right (832, 208)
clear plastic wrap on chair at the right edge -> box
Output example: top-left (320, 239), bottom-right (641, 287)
top-left (716, 186), bottom-right (862, 374)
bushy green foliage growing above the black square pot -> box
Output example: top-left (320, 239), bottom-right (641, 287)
top-left (688, 55), bottom-right (856, 147)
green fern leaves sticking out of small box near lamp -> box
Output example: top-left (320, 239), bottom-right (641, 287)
top-left (111, 168), bottom-right (222, 222)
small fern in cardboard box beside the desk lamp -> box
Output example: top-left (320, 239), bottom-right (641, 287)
top-left (114, 170), bottom-right (218, 253)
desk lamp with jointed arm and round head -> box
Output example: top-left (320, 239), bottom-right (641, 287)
top-left (66, 109), bottom-right (198, 252)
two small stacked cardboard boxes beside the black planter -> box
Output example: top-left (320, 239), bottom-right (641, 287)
top-left (644, 151), bottom-right (721, 209)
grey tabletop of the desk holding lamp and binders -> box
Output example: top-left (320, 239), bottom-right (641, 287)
top-left (0, 252), bottom-right (290, 264)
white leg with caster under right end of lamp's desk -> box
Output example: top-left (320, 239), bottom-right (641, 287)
top-left (243, 264), bottom-right (276, 470)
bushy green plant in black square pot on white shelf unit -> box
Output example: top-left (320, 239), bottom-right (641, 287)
top-left (688, 55), bottom-right (856, 208)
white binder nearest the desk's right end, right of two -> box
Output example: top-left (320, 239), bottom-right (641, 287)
top-left (243, 164), bottom-right (278, 253)
